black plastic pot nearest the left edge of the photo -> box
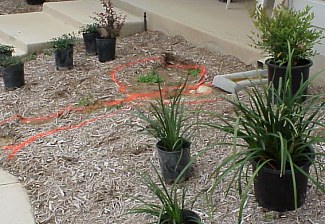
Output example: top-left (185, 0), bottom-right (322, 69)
top-left (2, 63), bottom-right (25, 90)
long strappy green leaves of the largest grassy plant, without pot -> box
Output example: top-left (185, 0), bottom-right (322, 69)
top-left (207, 47), bottom-right (325, 223)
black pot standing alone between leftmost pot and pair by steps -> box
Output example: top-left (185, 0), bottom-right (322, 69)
top-left (54, 45), bottom-right (73, 71)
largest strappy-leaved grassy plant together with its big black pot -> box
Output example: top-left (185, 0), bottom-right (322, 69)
top-left (208, 50), bottom-right (325, 223)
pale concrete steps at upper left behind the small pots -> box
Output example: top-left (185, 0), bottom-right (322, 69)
top-left (0, 0), bottom-right (144, 55)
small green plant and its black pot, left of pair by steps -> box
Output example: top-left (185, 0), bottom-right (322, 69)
top-left (50, 33), bottom-right (77, 71)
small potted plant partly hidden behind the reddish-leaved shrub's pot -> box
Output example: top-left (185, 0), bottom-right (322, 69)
top-left (80, 23), bottom-right (100, 55)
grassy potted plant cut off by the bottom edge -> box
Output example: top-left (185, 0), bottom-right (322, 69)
top-left (128, 163), bottom-right (201, 224)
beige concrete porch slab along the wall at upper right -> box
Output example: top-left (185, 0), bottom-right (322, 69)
top-left (112, 0), bottom-right (261, 64)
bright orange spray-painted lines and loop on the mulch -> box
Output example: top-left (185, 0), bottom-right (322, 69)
top-left (0, 57), bottom-right (220, 158)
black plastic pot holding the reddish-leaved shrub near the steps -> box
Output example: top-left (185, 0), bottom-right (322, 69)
top-left (96, 38), bottom-right (116, 63)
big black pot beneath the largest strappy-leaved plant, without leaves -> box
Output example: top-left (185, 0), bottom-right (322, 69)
top-left (252, 150), bottom-right (311, 212)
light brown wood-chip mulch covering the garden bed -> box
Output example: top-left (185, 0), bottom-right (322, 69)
top-left (0, 0), bottom-right (325, 224)
